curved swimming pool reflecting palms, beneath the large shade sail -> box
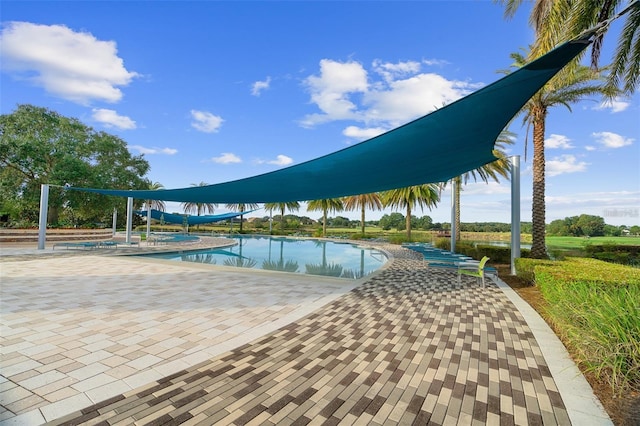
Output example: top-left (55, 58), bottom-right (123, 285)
top-left (145, 236), bottom-right (387, 279)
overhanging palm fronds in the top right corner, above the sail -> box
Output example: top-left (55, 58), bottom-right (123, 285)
top-left (495, 0), bottom-right (640, 94)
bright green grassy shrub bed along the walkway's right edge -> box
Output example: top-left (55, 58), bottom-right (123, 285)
top-left (536, 258), bottom-right (640, 394)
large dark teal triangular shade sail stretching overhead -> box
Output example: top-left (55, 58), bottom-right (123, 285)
top-left (67, 35), bottom-right (591, 203)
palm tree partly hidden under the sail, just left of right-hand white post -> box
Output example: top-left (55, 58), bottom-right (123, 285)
top-left (454, 130), bottom-right (515, 241)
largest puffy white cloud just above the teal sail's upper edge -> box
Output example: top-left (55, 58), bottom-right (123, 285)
top-left (301, 59), bottom-right (482, 131)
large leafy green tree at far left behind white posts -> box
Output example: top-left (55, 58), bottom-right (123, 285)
top-left (0, 105), bottom-right (149, 224)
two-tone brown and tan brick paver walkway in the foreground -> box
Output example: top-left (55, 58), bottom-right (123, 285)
top-left (40, 249), bottom-right (570, 425)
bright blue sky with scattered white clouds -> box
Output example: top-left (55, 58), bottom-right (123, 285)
top-left (0, 0), bottom-right (640, 225)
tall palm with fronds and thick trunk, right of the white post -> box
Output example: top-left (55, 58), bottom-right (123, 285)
top-left (504, 49), bottom-right (616, 259)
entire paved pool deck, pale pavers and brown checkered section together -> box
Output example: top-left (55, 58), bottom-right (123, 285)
top-left (0, 241), bottom-right (612, 426)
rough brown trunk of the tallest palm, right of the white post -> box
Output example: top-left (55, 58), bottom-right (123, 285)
top-left (531, 109), bottom-right (548, 259)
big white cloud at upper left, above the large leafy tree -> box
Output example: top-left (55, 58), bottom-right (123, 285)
top-left (0, 22), bottom-right (138, 105)
